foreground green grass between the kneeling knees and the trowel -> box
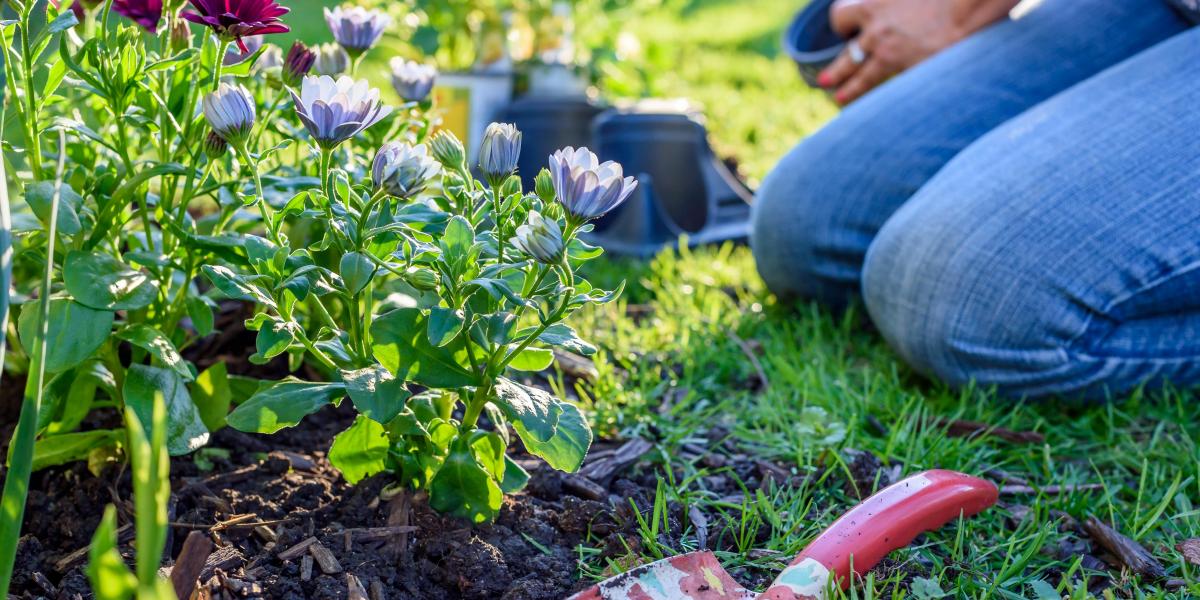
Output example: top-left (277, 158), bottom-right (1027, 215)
top-left (564, 247), bottom-right (1200, 598)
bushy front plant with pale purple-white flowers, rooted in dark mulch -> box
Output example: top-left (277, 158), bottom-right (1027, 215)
top-left (225, 120), bottom-right (635, 521)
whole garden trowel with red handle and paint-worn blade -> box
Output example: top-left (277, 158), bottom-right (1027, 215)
top-left (568, 470), bottom-right (998, 600)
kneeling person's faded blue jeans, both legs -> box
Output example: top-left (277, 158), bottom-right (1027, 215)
top-left (751, 0), bottom-right (1200, 398)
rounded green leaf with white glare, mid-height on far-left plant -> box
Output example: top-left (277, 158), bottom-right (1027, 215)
top-left (62, 250), bottom-right (158, 311)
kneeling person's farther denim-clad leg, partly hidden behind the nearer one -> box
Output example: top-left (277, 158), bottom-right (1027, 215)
top-left (751, 0), bottom-right (1186, 306)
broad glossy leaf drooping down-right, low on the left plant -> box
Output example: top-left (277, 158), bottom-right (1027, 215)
top-left (124, 365), bottom-right (209, 456)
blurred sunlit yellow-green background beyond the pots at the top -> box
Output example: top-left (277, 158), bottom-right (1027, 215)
top-left (279, 0), bottom-right (835, 186)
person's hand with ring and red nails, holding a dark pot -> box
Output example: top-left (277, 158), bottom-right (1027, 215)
top-left (817, 0), bottom-right (971, 104)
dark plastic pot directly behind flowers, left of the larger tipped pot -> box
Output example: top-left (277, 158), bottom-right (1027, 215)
top-left (503, 96), bottom-right (604, 190)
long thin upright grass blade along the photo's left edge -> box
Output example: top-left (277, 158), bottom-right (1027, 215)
top-left (0, 130), bottom-right (66, 598)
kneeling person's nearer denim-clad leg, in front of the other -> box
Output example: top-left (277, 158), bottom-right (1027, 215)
top-left (863, 29), bottom-right (1200, 397)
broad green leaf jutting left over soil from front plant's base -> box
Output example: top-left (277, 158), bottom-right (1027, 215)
top-left (226, 377), bottom-right (346, 433)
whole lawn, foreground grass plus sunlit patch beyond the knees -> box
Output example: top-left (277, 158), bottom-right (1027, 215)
top-left (554, 0), bottom-right (1200, 598)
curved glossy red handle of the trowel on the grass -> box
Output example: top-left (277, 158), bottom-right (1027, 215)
top-left (760, 470), bottom-right (998, 600)
